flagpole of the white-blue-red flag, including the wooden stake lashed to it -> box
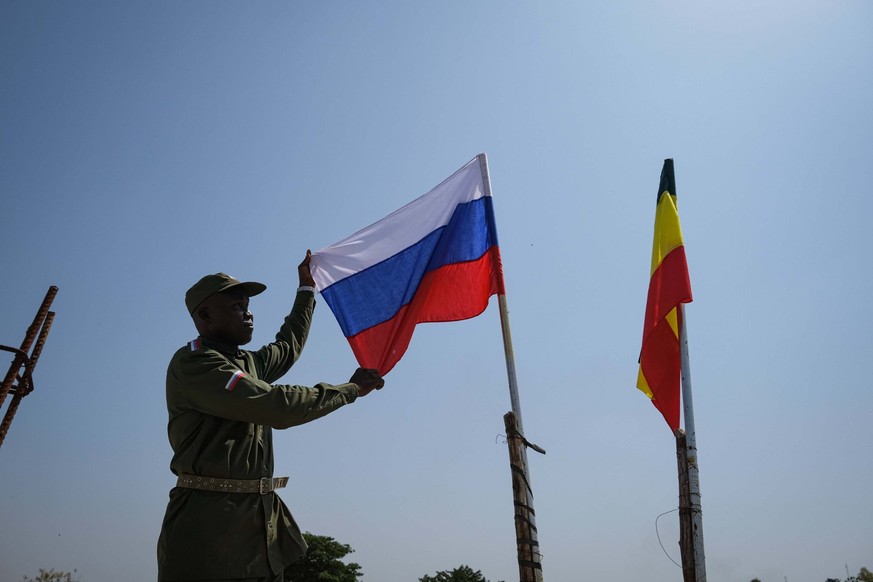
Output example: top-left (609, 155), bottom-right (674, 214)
top-left (477, 153), bottom-right (545, 582)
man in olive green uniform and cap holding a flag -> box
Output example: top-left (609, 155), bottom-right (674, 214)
top-left (158, 251), bottom-right (384, 582)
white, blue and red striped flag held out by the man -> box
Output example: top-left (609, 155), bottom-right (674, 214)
top-left (310, 154), bottom-right (505, 375)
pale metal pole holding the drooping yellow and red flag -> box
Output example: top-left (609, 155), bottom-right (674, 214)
top-left (679, 303), bottom-right (706, 582)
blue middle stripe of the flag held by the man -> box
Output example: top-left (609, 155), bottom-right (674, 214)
top-left (321, 196), bottom-right (497, 337)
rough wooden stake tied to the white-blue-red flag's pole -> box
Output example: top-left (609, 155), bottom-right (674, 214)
top-left (503, 412), bottom-right (543, 582)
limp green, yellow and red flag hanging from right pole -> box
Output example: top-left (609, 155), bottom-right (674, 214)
top-left (637, 159), bottom-right (691, 431)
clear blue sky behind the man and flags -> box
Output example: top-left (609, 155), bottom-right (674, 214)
top-left (0, 0), bottom-right (873, 582)
